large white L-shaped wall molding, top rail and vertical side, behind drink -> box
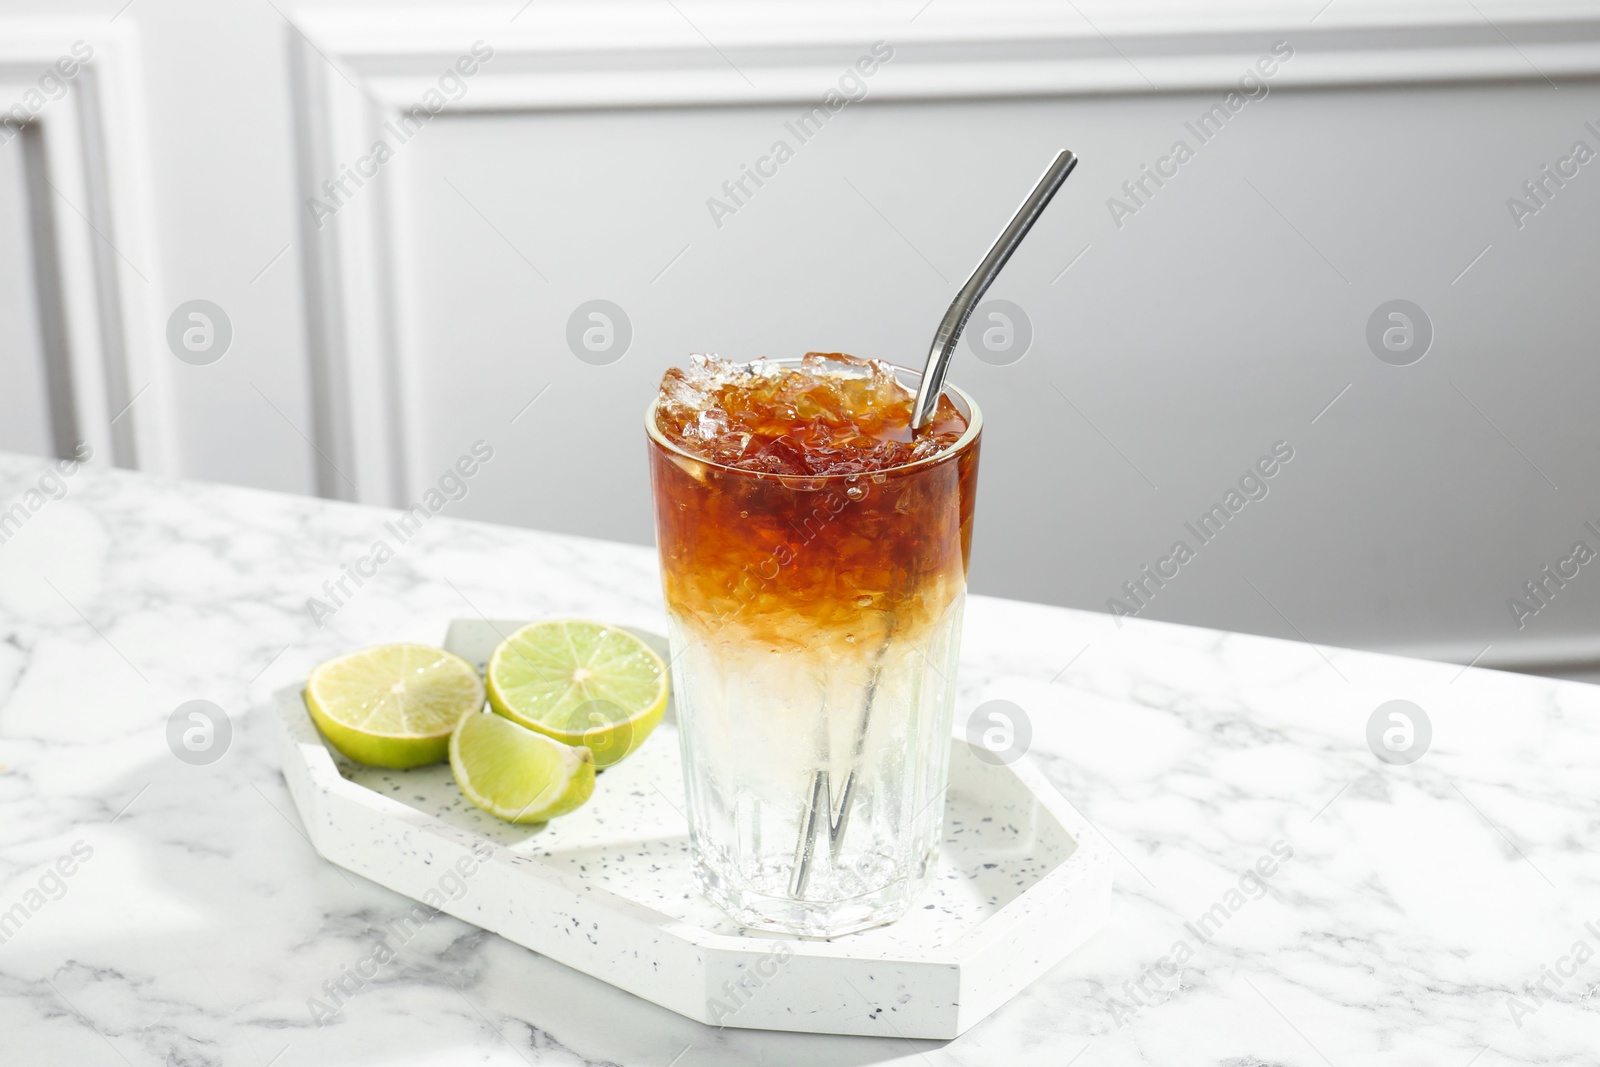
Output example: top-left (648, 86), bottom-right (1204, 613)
top-left (288, 0), bottom-right (1600, 506)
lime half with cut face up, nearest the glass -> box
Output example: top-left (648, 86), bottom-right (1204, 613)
top-left (488, 619), bottom-right (667, 768)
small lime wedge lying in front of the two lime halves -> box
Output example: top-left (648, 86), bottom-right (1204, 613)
top-left (450, 713), bottom-right (595, 822)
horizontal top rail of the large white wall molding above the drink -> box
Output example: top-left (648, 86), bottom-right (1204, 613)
top-left (324, 0), bottom-right (1600, 110)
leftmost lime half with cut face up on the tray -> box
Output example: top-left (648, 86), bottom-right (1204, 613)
top-left (306, 645), bottom-right (483, 768)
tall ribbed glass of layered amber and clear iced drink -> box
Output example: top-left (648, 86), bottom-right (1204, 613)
top-left (646, 352), bottom-right (981, 936)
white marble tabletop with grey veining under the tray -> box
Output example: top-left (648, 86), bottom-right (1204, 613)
top-left (0, 456), bottom-right (1600, 1067)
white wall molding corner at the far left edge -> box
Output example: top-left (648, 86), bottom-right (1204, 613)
top-left (0, 18), bottom-right (174, 472)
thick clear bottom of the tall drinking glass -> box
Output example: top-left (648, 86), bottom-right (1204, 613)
top-left (694, 849), bottom-right (939, 937)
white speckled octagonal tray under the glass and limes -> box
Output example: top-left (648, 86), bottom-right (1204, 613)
top-left (268, 621), bottom-right (1110, 1038)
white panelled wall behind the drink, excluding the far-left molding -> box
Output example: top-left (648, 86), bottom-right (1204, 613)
top-left (0, 0), bottom-right (1600, 662)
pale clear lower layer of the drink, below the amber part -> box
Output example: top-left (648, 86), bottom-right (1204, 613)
top-left (670, 597), bottom-right (963, 936)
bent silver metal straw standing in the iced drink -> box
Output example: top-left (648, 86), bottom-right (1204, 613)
top-left (789, 149), bottom-right (1078, 901)
